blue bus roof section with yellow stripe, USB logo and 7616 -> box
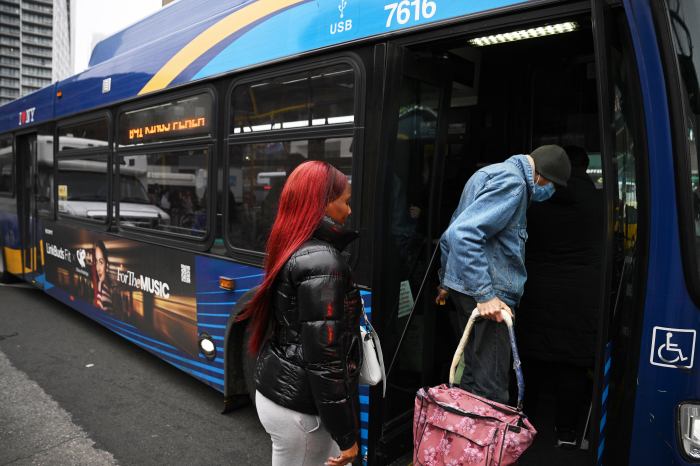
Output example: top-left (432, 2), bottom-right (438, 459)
top-left (0, 0), bottom-right (532, 133)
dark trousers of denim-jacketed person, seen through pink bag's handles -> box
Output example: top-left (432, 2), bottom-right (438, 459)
top-left (450, 290), bottom-right (511, 404)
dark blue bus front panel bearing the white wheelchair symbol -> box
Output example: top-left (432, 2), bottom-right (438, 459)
top-left (625, 0), bottom-right (700, 465)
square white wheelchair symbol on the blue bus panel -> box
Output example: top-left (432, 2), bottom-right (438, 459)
top-left (649, 327), bottom-right (695, 369)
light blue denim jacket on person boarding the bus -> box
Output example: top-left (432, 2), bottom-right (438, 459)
top-left (440, 155), bottom-right (534, 306)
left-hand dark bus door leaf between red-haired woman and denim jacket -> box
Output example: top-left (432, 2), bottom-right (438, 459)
top-left (370, 44), bottom-right (451, 464)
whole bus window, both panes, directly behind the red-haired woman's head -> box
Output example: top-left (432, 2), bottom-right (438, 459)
top-left (227, 63), bottom-right (356, 252)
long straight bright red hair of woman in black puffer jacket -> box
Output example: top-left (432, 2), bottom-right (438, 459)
top-left (236, 160), bottom-right (348, 354)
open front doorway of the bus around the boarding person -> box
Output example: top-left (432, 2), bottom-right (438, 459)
top-left (369, 0), bottom-right (646, 465)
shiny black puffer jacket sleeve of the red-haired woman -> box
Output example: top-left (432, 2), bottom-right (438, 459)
top-left (297, 257), bottom-right (359, 450)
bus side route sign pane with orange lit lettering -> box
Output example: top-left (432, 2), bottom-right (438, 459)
top-left (119, 93), bottom-right (213, 146)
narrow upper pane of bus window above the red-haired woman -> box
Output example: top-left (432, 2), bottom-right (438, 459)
top-left (231, 64), bottom-right (355, 134)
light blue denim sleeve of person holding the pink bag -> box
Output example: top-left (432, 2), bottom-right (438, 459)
top-left (444, 179), bottom-right (527, 303)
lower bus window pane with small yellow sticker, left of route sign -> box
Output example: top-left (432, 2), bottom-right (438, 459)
top-left (56, 154), bottom-right (109, 223)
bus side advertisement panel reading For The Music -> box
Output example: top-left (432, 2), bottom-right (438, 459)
top-left (43, 222), bottom-right (224, 392)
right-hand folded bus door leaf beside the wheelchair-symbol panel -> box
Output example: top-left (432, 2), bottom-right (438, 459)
top-left (589, 0), bottom-right (648, 464)
